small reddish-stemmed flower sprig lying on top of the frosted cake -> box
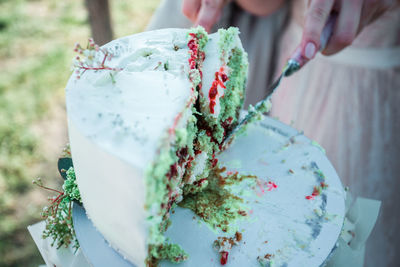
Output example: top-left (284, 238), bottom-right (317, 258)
top-left (72, 38), bottom-right (122, 79)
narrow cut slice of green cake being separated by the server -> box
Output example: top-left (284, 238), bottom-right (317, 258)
top-left (200, 28), bottom-right (247, 144)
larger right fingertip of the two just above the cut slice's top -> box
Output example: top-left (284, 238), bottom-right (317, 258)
top-left (195, 0), bottom-right (223, 32)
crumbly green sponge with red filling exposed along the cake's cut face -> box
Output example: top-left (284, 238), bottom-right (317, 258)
top-left (142, 27), bottom-right (247, 266)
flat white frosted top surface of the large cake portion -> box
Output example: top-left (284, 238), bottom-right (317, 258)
top-left (66, 29), bottom-right (192, 168)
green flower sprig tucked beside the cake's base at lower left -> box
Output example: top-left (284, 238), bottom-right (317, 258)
top-left (33, 167), bottom-right (81, 249)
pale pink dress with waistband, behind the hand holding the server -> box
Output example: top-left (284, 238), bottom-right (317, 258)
top-left (271, 1), bottom-right (400, 266)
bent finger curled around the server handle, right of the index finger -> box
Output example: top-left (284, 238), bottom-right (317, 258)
top-left (322, 0), bottom-right (363, 55)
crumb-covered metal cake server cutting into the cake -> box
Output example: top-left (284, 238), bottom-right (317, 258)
top-left (222, 13), bottom-right (337, 147)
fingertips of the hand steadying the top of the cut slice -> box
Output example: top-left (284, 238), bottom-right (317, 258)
top-left (182, 0), bottom-right (228, 32)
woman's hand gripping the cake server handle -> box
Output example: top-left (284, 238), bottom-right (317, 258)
top-left (300, 0), bottom-right (399, 59)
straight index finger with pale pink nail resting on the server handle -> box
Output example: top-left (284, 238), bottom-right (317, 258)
top-left (301, 0), bottom-right (334, 59)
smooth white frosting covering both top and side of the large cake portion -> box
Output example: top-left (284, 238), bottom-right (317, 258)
top-left (66, 29), bottom-right (193, 266)
